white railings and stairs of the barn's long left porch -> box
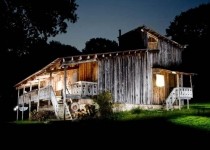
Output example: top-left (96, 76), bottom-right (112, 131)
top-left (18, 81), bottom-right (97, 120)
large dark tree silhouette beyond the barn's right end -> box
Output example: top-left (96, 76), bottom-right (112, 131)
top-left (166, 3), bottom-right (210, 99)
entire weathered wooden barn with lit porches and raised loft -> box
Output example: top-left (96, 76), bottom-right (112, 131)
top-left (15, 26), bottom-right (193, 119)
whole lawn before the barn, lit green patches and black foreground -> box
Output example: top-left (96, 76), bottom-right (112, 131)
top-left (1, 103), bottom-right (210, 146)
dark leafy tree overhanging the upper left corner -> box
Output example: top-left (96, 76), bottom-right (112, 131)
top-left (0, 0), bottom-right (78, 55)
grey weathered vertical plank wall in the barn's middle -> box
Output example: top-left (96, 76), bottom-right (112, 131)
top-left (98, 52), bottom-right (152, 104)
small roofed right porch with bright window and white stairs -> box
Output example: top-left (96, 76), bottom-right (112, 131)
top-left (153, 68), bottom-right (195, 110)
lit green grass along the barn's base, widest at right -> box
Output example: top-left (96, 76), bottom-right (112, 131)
top-left (11, 103), bottom-right (210, 132)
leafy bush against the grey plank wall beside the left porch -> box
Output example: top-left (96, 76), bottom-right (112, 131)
top-left (94, 91), bottom-right (113, 119)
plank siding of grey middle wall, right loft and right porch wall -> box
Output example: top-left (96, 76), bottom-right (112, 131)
top-left (98, 40), bottom-right (182, 104)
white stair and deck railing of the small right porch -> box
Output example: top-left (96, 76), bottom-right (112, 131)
top-left (166, 87), bottom-right (193, 110)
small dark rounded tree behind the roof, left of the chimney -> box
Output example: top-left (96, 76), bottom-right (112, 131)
top-left (82, 38), bottom-right (118, 54)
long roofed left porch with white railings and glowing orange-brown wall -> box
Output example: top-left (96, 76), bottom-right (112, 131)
top-left (15, 55), bottom-right (98, 120)
